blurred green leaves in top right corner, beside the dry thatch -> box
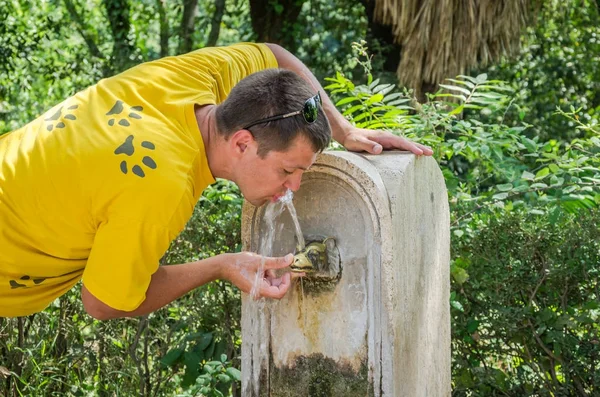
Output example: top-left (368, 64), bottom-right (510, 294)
top-left (487, 0), bottom-right (600, 141)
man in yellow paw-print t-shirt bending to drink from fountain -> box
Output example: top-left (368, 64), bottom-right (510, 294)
top-left (0, 43), bottom-right (431, 319)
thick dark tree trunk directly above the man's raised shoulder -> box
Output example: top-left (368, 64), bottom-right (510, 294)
top-left (250, 0), bottom-right (304, 52)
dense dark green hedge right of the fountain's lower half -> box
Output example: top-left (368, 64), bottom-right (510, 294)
top-left (452, 210), bottom-right (600, 396)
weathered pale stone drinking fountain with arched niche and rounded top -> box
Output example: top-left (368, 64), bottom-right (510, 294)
top-left (242, 152), bottom-right (450, 397)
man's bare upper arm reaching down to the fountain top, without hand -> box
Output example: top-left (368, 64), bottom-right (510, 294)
top-left (266, 44), bottom-right (351, 144)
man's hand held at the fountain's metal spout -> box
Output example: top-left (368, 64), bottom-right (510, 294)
top-left (222, 252), bottom-right (302, 299)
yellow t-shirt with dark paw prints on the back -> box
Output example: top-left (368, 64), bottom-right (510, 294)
top-left (0, 43), bottom-right (277, 316)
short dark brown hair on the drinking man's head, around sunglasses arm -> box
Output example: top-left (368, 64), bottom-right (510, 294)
top-left (216, 69), bottom-right (331, 157)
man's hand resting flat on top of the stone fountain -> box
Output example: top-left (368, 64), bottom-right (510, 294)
top-left (340, 127), bottom-right (433, 156)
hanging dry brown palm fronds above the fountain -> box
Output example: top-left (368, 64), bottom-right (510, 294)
top-left (375, 0), bottom-right (540, 93)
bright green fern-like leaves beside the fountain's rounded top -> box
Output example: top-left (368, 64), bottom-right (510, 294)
top-left (327, 41), bottom-right (600, 237)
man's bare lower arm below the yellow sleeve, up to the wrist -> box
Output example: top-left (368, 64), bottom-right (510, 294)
top-left (82, 255), bottom-right (226, 320)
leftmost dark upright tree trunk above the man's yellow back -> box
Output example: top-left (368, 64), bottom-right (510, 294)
top-left (103, 0), bottom-right (134, 73)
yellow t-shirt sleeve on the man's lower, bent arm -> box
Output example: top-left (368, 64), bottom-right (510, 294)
top-left (83, 220), bottom-right (170, 311)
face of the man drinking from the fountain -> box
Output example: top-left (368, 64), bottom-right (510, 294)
top-left (236, 135), bottom-right (317, 206)
